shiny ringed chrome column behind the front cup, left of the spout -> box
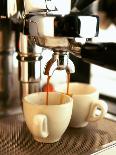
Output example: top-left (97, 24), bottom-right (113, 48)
top-left (17, 33), bottom-right (43, 101)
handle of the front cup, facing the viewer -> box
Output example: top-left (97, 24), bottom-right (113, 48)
top-left (33, 114), bottom-right (48, 138)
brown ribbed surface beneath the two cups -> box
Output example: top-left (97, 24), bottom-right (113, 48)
top-left (0, 114), bottom-right (116, 155)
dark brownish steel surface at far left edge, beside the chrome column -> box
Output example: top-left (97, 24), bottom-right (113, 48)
top-left (0, 19), bottom-right (19, 109)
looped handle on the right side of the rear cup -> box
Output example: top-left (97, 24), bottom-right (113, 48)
top-left (87, 100), bottom-right (108, 122)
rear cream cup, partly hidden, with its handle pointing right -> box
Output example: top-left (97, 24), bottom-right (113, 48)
top-left (55, 82), bottom-right (108, 127)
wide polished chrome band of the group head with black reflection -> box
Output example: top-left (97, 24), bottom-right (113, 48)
top-left (24, 12), bottom-right (99, 38)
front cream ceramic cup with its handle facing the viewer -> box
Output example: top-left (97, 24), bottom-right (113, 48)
top-left (23, 92), bottom-right (73, 143)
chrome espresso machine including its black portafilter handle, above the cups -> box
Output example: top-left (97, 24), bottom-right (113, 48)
top-left (0, 0), bottom-right (116, 108)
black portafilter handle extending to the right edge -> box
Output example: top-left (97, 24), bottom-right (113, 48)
top-left (81, 43), bottom-right (116, 70)
